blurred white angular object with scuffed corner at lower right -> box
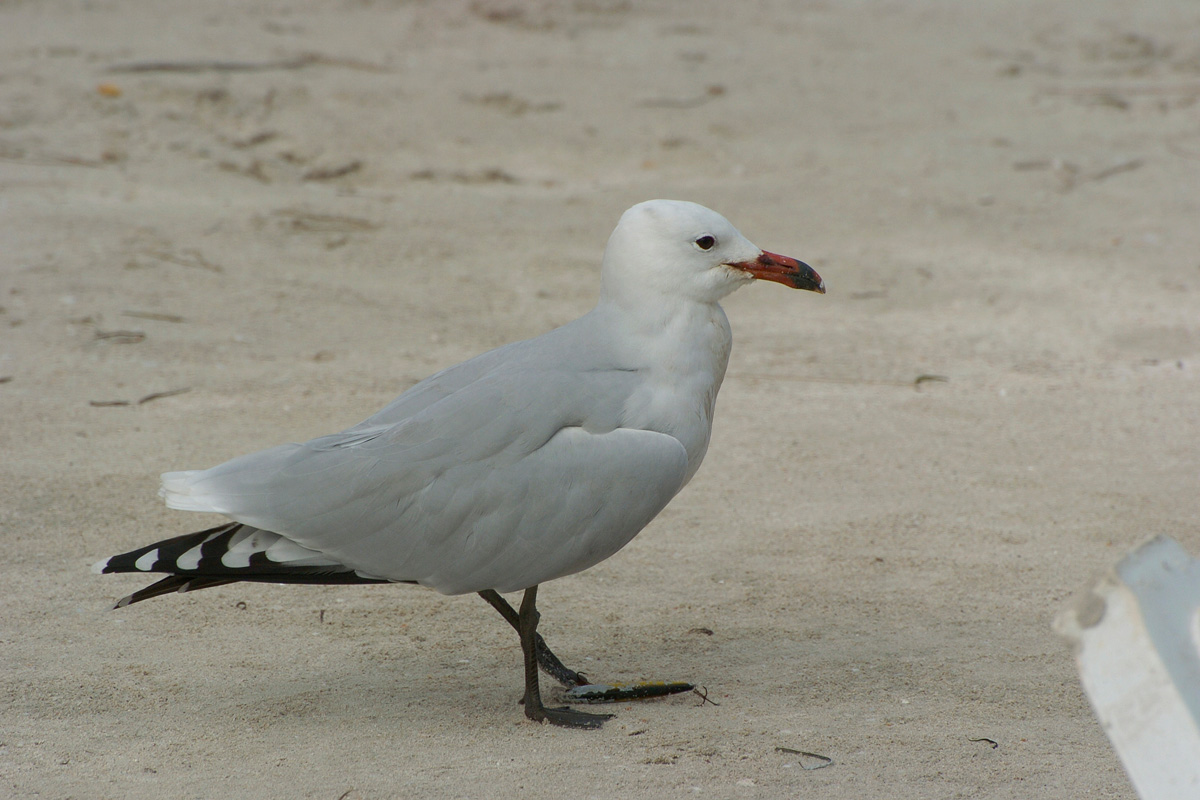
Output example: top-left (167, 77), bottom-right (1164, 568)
top-left (1055, 536), bottom-right (1200, 800)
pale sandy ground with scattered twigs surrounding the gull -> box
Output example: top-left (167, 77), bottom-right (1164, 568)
top-left (0, 0), bottom-right (1200, 800)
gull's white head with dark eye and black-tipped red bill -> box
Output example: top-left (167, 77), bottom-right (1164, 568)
top-left (601, 200), bottom-right (824, 303)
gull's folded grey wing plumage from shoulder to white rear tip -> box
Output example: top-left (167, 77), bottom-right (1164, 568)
top-left (163, 371), bottom-right (688, 594)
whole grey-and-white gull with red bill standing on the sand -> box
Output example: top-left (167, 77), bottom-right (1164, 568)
top-left (94, 200), bottom-right (824, 728)
